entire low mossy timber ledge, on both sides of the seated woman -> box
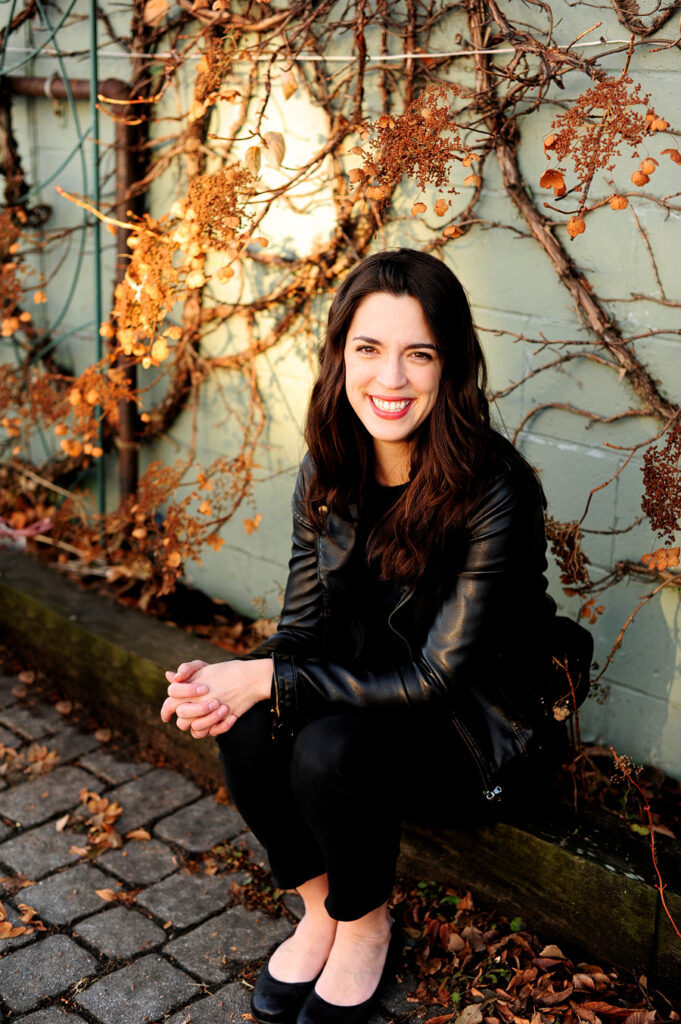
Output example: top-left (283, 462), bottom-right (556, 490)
top-left (0, 550), bottom-right (681, 991)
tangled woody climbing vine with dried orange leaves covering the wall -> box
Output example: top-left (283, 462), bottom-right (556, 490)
top-left (0, 0), bottom-right (681, 674)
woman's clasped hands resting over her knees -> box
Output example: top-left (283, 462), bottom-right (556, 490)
top-left (161, 657), bottom-right (272, 739)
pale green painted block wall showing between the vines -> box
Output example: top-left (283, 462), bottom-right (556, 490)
top-left (6, 0), bottom-right (681, 777)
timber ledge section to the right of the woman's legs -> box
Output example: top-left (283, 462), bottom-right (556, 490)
top-left (401, 808), bottom-right (681, 993)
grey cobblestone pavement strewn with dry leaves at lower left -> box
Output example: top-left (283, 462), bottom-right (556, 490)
top-left (0, 676), bottom-right (432, 1024)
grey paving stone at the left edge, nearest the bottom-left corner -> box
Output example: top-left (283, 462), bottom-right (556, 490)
top-left (0, 935), bottom-right (97, 1012)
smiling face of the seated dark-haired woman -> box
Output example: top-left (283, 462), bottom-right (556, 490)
top-left (344, 292), bottom-right (442, 471)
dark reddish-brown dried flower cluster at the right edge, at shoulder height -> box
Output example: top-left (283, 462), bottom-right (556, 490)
top-left (641, 420), bottom-right (681, 542)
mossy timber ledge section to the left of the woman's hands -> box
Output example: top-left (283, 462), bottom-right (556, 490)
top-left (0, 549), bottom-right (230, 783)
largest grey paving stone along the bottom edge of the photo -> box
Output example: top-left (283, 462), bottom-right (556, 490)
top-left (76, 953), bottom-right (197, 1024)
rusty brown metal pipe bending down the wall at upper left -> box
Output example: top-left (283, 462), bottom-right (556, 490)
top-left (4, 69), bottom-right (139, 499)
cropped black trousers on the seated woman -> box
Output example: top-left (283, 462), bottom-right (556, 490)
top-left (217, 701), bottom-right (482, 921)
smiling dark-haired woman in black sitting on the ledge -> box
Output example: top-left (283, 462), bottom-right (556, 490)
top-left (162, 249), bottom-right (589, 1024)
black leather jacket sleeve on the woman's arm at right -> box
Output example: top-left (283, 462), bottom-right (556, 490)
top-left (273, 472), bottom-right (546, 733)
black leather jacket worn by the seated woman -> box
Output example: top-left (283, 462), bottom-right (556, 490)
top-left (249, 457), bottom-right (555, 799)
